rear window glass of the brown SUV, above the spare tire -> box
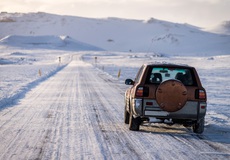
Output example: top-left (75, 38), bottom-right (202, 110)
top-left (146, 67), bottom-right (197, 86)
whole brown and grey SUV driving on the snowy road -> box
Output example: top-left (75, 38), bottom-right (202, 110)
top-left (124, 63), bottom-right (207, 133)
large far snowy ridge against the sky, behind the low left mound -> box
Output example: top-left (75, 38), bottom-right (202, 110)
top-left (0, 12), bottom-right (230, 56)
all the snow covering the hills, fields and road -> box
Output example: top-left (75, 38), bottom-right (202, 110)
top-left (0, 13), bottom-right (230, 159)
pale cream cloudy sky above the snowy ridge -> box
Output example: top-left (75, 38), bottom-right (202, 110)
top-left (0, 0), bottom-right (230, 28)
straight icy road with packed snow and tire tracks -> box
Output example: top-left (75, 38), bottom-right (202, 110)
top-left (0, 56), bottom-right (230, 160)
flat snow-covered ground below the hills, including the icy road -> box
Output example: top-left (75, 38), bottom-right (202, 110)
top-left (0, 49), bottom-right (230, 160)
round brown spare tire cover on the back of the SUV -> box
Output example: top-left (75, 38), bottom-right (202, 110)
top-left (156, 79), bottom-right (187, 112)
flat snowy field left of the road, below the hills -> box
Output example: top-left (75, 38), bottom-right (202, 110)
top-left (0, 50), bottom-right (72, 108)
